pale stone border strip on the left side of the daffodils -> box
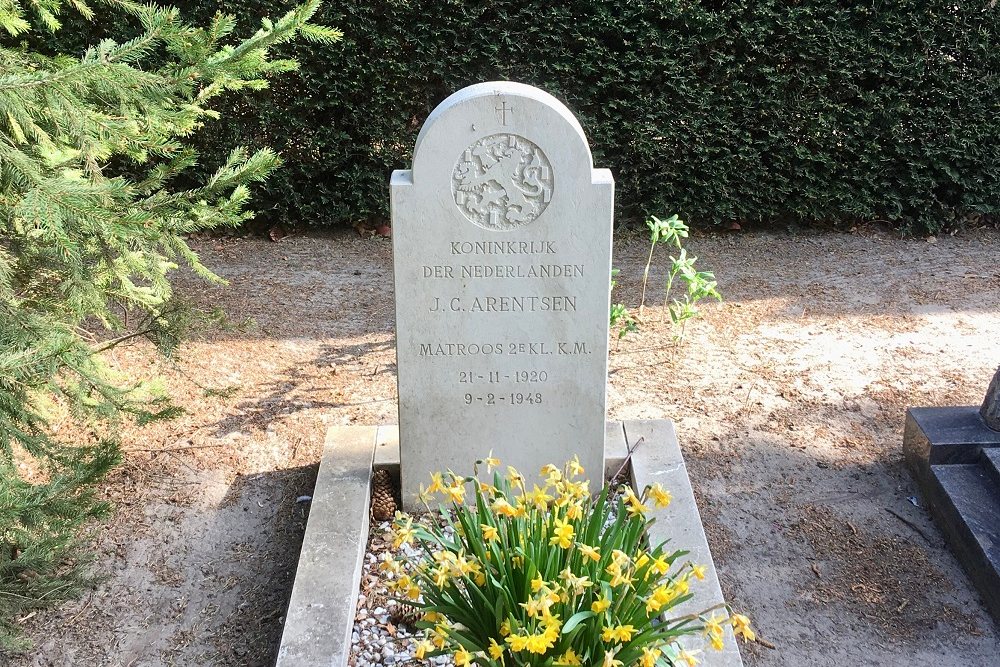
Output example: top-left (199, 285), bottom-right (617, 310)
top-left (275, 426), bottom-right (378, 667)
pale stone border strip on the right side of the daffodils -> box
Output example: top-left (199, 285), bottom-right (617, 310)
top-left (624, 419), bottom-right (743, 667)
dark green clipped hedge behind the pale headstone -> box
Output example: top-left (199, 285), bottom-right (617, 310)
top-left (35, 0), bottom-right (1000, 230)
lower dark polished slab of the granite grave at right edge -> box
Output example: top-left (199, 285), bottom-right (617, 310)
top-left (925, 457), bottom-right (1000, 622)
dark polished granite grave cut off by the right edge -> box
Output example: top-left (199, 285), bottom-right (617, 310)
top-left (903, 368), bottom-right (1000, 623)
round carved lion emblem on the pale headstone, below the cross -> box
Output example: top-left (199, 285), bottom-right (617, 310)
top-left (451, 134), bottom-right (552, 231)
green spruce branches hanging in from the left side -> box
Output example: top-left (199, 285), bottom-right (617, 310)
top-left (0, 0), bottom-right (341, 650)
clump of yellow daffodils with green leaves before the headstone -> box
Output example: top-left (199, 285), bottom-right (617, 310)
top-left (382, 453), bottom-right (755, 667)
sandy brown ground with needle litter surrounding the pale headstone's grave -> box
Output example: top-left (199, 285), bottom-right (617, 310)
top-left (0, 228), bottom-right (1000, 667)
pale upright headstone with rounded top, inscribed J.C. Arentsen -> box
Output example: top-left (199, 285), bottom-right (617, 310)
top-left (391, 82), bottom-right (614, 509)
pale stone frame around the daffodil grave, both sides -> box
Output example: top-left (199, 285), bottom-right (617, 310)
top-left (275, 426), bottom-right (743, 667)
